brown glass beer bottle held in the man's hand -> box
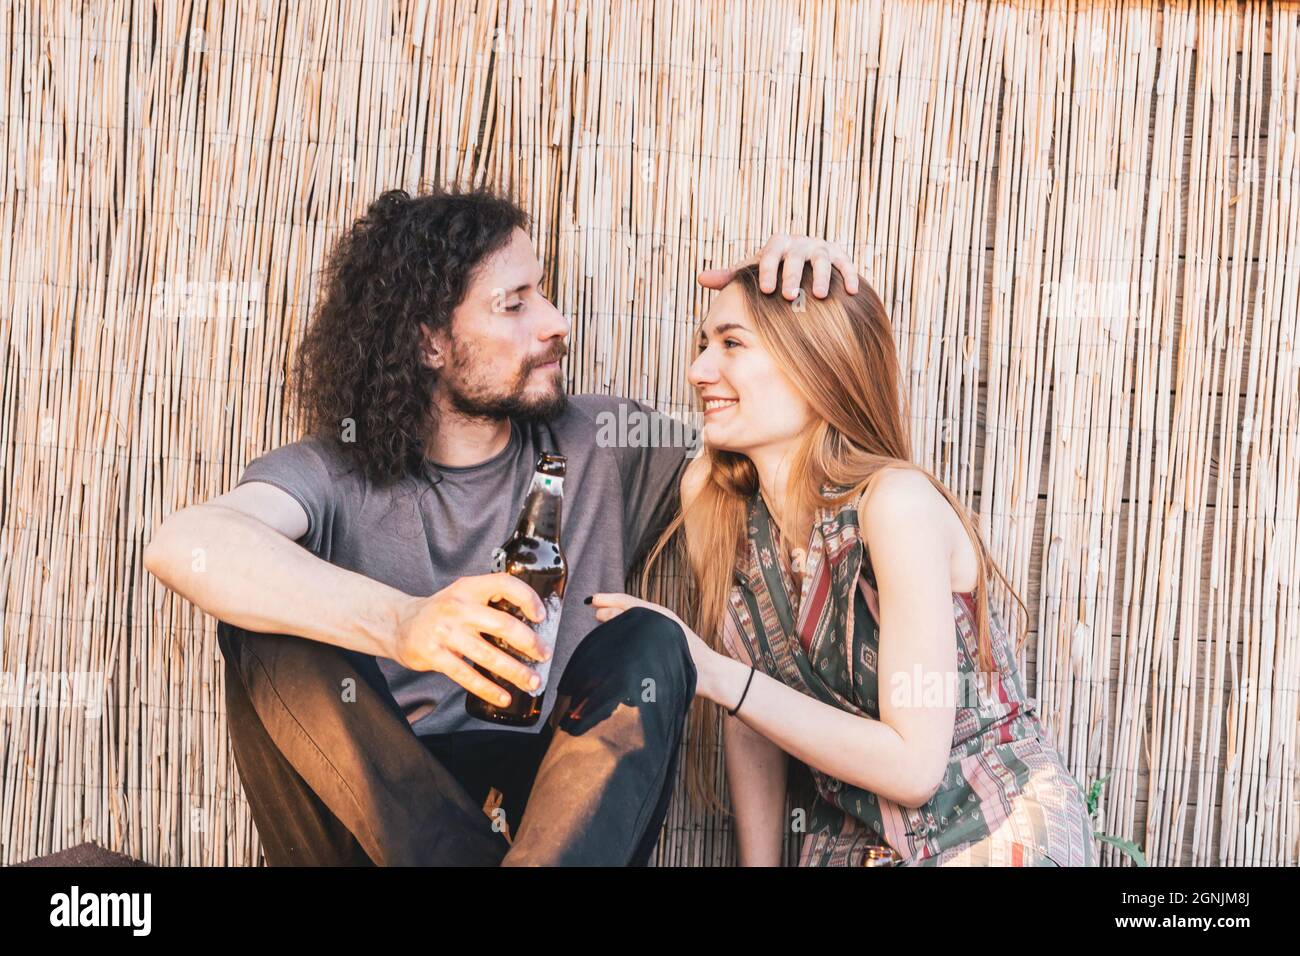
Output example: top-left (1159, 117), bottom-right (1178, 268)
top-left (465, 451), bottom-right (568, 727)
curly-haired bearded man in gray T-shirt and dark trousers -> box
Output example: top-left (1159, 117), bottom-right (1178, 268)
top-left (144, 190), bottom-right (855, 865)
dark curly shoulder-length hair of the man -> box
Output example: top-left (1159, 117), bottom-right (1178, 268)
top-left (293, 186), bottom-right (530, 485)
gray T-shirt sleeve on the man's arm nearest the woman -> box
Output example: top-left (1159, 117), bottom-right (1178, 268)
top-left (623, 399), bottom-right (698, 568)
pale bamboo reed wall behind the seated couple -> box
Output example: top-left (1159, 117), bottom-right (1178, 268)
top-left (0, 0), bottom-right (1300, 865)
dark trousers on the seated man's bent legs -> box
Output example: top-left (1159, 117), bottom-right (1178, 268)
top-left (217, 607), bottom-right (697, 866)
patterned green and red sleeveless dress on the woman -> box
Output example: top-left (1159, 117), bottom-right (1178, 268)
top-left (723, 488), bottom-right (1099, 866)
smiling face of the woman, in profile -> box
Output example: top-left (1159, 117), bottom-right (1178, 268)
top-left (686, 284), bottom-right (813, 454)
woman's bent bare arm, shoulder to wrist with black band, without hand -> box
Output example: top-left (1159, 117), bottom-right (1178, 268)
top-left (699, 471), bottom-right (957, 806)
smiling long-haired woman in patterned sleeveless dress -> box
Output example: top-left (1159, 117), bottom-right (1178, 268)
top-left (592, 265), bottom-right (1097, 866)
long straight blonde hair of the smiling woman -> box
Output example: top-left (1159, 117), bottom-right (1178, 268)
top-left (640, 265), bottom-right (1028, 813)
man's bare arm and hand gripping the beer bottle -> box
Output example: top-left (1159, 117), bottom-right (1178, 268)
top-left (144, 481), bottom-right (550, 705)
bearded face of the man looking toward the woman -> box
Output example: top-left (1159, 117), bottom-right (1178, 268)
top-left (429, 229), bottom-right (569, 421)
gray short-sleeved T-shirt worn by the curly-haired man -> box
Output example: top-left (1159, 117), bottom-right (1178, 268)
top-left (238, 394), bottom-right (696, 736)
